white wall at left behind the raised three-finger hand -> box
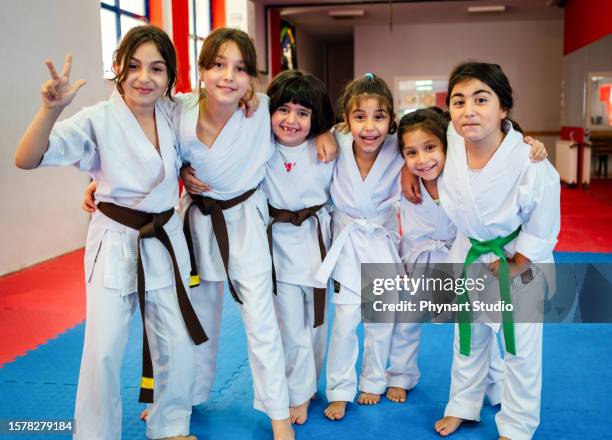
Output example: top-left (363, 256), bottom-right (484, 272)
top-left (0, 0), bottom-right (110, 275)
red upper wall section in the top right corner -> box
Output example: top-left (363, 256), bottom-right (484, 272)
top-left (563, 0), bottom-right (612, 55)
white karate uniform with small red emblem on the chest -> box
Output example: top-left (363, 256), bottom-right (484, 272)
top-left (262, 140), bottom-right (334, 406)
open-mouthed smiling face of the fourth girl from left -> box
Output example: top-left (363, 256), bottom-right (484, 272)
top-left (347, 96), bottom-right (391, 155)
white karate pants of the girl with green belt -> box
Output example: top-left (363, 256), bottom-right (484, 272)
top-left (444, 323), bottom-right (543, 440)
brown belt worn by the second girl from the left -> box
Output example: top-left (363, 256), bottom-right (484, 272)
top-left (183, 188), bottom-right (257, 304)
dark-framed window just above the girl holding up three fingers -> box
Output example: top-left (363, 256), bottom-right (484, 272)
top-left (100, 0), bottom-right (149, 79)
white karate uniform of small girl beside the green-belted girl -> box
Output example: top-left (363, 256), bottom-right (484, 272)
top-left (387, 187), bottom-right (503, 405)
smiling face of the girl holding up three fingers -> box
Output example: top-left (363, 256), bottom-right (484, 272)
top-left (115, 42), bottom-right (168, 109)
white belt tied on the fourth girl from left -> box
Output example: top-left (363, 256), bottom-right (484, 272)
top-left (315, 209), bottom-right (400, 284)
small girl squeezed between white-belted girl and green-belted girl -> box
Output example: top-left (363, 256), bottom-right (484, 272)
top-left (387, 107), bottom-right (503, 405)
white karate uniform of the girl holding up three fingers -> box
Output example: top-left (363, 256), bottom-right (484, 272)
top-left (40, 91), bottom-right (195, 440)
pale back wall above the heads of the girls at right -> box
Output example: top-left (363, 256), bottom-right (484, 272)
top-left (355, 21), bottom-right (563, 148)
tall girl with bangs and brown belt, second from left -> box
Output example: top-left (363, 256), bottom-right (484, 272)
top-left (173, 28), bottom-right (294, 440)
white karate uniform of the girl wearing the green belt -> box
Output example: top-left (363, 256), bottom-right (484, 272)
top-left (439, 125), bottom-right (560, 440)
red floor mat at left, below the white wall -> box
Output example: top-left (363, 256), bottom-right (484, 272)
top-left (0, 249), bottom-right (85, 366)
